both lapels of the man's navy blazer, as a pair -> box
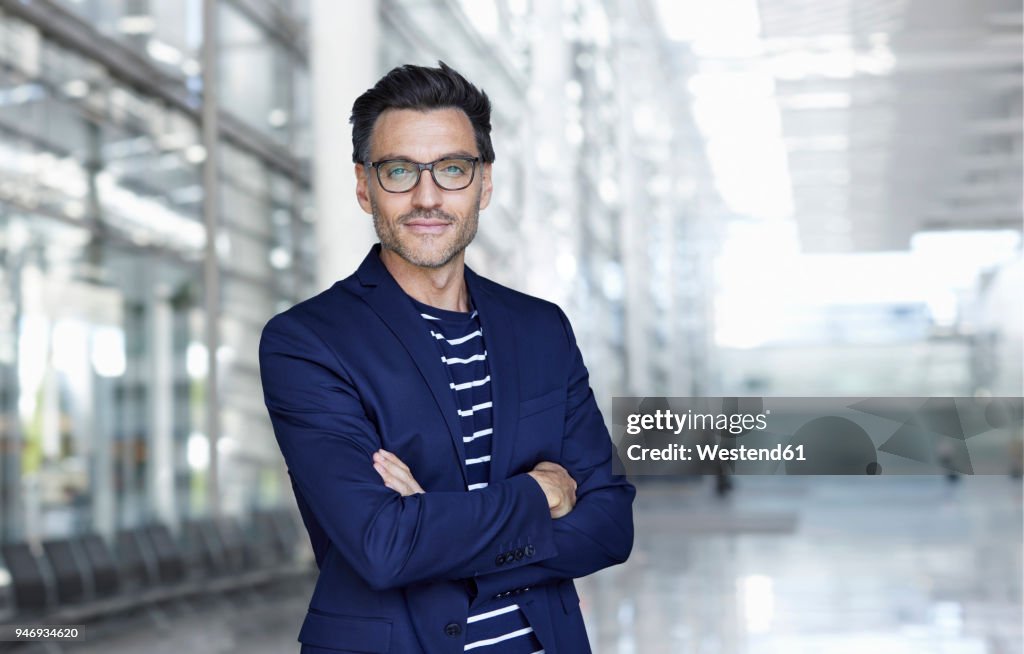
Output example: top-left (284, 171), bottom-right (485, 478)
top-left (355, 244), bottom-right (519, 484)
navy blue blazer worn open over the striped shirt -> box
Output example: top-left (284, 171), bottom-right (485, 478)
top-left (259, 245), bottom-right (636, 654)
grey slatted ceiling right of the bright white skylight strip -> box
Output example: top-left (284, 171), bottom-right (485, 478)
top-left (758, 0), bottom-right (1024, 252)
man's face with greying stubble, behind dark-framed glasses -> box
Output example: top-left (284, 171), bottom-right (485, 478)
top-left (355, 108), bottom-right (492, 268)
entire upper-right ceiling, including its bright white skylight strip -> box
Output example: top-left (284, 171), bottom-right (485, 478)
top-left (652, 0), bottom-right (1024, 253)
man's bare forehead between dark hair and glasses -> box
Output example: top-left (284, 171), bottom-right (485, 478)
top-left (370, 108), bottom-right (478, 162)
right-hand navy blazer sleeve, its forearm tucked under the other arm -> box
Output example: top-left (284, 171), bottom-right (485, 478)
top-left (471, 309), bottom-right (636, 607)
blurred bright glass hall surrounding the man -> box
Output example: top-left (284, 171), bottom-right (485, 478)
top-left (0, 0), bottom-right (1024, 654)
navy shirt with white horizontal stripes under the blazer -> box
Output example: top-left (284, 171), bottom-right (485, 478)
top-left (413, 300), bottom-right (544, 654)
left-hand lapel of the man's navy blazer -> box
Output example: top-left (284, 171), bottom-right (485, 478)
top-left (356, 245), bottom-right (468, 487)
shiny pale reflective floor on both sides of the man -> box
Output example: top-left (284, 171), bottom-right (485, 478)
top-left (14, 477), bottom-right (1024, 654)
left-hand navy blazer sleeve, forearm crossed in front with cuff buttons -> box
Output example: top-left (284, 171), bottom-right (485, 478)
top-left (259, 313), bottom-right (556, 590)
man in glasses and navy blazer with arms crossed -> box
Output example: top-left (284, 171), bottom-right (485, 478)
top-left (260, 63), bottom-right (635, 654)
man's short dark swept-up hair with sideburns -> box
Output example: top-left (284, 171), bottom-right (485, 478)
top-left (348, 61), bottom-right (495, 164)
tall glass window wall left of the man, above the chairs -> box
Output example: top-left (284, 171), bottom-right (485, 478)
top-left (0, 7), bottom-right (313, 540)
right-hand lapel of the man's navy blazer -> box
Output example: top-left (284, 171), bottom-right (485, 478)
top-left (466, 266), bottom-right (519, 483)
